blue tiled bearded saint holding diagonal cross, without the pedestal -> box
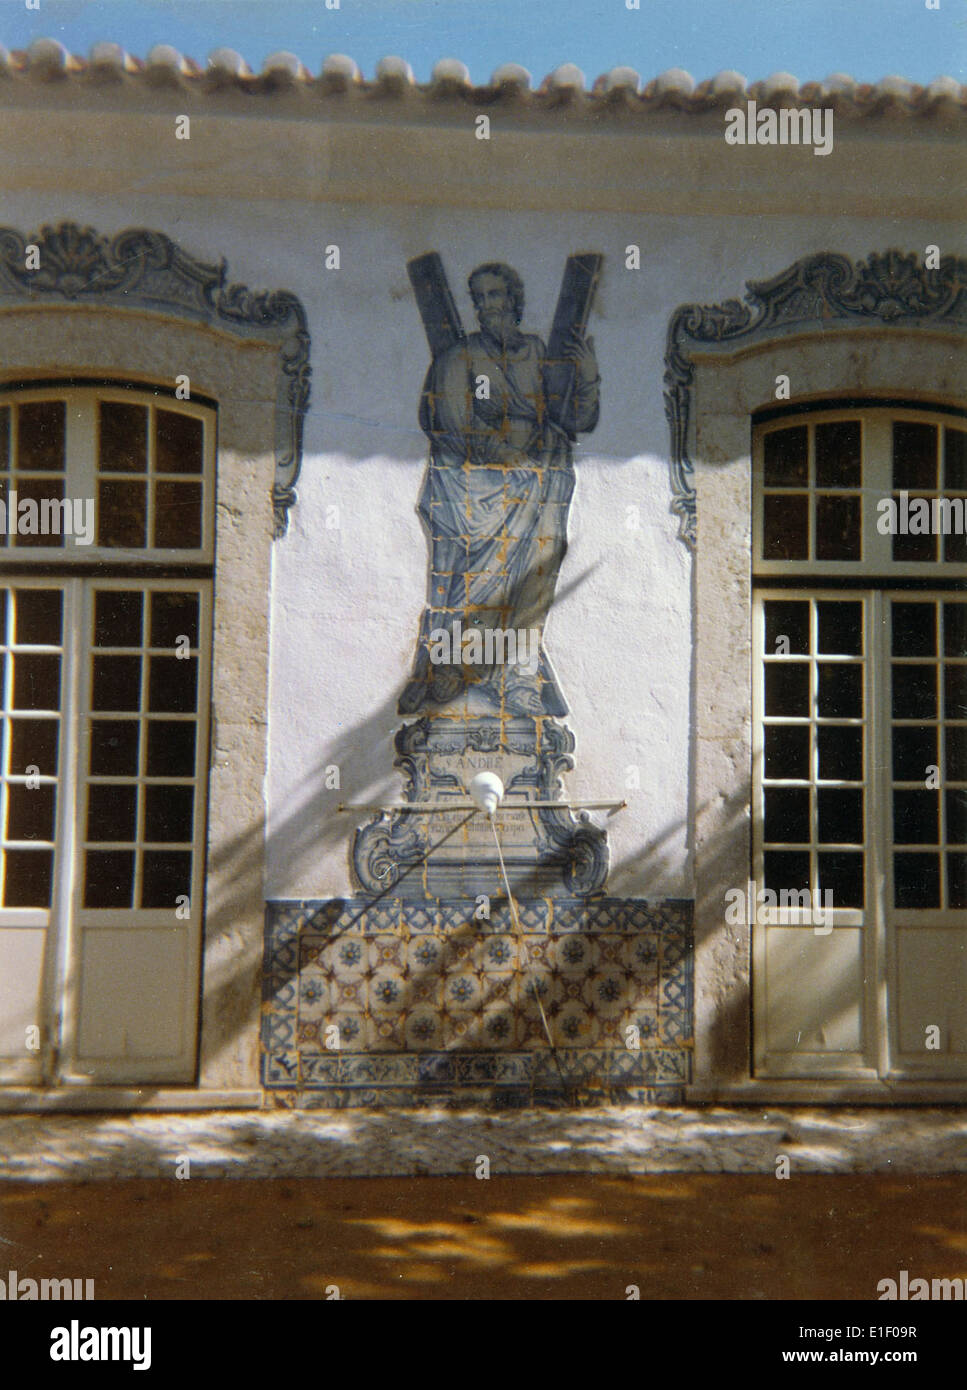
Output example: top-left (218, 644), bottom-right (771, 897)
top-left (400, 257), bottom-right (600, 716)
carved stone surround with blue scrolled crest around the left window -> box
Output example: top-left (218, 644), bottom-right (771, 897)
top-left (0, 225), bottom-right (308, 1109)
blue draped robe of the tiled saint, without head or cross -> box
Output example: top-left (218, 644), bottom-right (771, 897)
top-left (400, 334), bottom-right (599, 714)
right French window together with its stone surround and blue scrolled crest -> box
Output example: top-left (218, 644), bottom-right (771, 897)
top-left (666, 250), bottom-right (967, 1101)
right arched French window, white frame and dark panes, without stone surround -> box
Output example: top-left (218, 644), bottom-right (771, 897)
top-left (753, 402), bottom-right (967, 1079)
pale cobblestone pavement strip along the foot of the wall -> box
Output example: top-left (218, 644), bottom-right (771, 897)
top-left (0, 1106), bottom-right (967, 1182)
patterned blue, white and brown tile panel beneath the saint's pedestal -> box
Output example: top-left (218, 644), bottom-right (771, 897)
top-left (261, 898), bottom-right (693, 1109)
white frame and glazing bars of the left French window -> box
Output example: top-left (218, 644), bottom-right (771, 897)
top-left (0, 381), bottom-right (217, 1087)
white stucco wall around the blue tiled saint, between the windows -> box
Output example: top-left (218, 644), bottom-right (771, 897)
top-left (267, 209), bottom-right (961, 898)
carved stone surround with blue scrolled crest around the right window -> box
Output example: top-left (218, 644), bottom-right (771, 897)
top-left (666, 253), bottom-right (967, 1099)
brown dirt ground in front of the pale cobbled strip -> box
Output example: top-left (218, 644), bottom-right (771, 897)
top-left (0, 1175), bottom-right (967, 1301)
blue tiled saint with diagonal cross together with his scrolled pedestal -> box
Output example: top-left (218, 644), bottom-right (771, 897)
top-left (354, 252), bottom-right (607, 895)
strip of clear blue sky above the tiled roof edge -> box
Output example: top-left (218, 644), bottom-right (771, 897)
top-left (0, 0), bottom-right (967, 82)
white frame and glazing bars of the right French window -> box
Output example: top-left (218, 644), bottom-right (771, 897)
top-left (752, 400), bottom-right (967, 1083)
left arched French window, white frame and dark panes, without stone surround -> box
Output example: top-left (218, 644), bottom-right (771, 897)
top-left (0, 381), bottom-right (217, 1084)
